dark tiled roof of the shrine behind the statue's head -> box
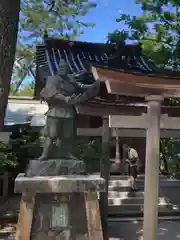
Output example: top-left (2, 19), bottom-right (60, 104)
top-left (36, 39), bottom-right (156, 78)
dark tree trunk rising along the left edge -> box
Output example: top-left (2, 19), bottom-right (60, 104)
top-left (0, 0), bottom-right (20, 131)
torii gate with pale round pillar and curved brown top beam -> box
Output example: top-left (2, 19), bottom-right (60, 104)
top-left (92, 67), bottom-right (180, 240)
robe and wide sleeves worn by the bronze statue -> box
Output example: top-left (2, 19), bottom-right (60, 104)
top-left (41, 75), bottom-right (99, 158)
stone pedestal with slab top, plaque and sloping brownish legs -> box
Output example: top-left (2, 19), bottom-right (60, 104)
top-left (15, 174), bottom-right (104, 240)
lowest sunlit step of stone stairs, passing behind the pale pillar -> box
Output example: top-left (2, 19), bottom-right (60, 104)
top-left (108, 197), bottom-right (169, 206)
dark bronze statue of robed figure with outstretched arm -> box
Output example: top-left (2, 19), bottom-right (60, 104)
top-left (39, 62), bottom-right (100, 161)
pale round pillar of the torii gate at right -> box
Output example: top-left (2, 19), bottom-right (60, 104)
top-left (143, 96), bottom-right (163, 240)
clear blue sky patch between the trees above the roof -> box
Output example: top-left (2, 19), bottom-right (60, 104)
top-left (79, 0), bottom-right (141, 42)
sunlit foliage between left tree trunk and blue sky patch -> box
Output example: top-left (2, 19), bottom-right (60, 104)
top-left (13, 0), bottom-right (96, 94)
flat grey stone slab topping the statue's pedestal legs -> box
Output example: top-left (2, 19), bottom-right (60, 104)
top-left (15, 174), bottom-right (105, 194)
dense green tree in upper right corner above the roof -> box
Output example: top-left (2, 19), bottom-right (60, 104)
top-left (108, 0), bottom-right (180, 70)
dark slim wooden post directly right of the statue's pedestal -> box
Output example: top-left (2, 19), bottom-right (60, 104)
top-left (100, 117), bottom-right (110, 240)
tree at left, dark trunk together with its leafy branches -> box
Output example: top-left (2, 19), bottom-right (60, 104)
top-left (0, 0), bottom-right (95, 131)
